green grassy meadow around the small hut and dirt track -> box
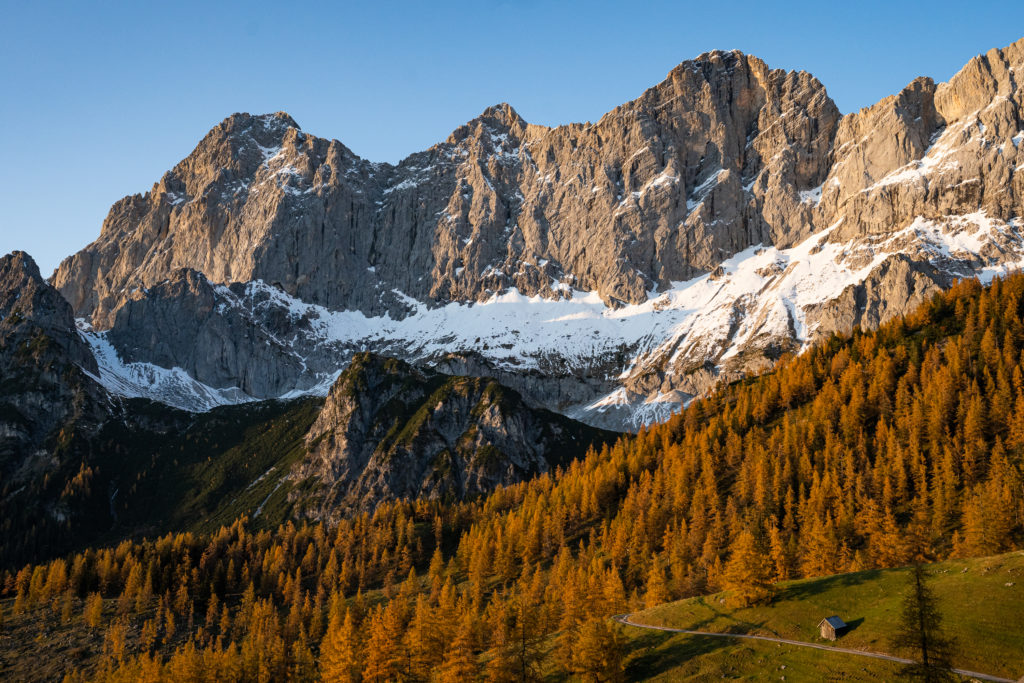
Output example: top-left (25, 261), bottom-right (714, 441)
top-left (625, 552), bottom-right (1024, 681)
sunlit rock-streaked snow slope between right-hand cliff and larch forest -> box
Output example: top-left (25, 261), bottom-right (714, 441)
top-left (593, 212), bottom-right (1024, 425)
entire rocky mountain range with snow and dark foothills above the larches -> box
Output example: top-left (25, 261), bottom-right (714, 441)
top-left (0, 40), bottom-right (1024, 563)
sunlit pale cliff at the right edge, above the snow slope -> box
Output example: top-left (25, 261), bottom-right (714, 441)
top-left (814, 40), bottom-right (1024, 240)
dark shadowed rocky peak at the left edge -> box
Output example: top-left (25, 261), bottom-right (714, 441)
top-left (0, 252), bottom-right (108, 567)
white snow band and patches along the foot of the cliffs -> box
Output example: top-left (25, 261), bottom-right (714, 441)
top-left (82, 210), bottom-right (1024, 426)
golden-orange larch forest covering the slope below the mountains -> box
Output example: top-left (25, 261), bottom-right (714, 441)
top-left (4, 275), bottom-right (1024, 681)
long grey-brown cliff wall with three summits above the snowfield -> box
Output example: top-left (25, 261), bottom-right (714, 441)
top-left (53, 52), bottom-right (839, 329)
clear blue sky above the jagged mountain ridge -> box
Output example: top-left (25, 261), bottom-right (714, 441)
top-left (0, 0), bottom-right (1024, 274)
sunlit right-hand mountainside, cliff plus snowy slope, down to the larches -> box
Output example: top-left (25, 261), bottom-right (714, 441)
top-left (591, 40), bottom-right (1024, 422)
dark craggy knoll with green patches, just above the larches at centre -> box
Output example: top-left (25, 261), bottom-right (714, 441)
top-left (293, 353), bottom-right (613, 518)
